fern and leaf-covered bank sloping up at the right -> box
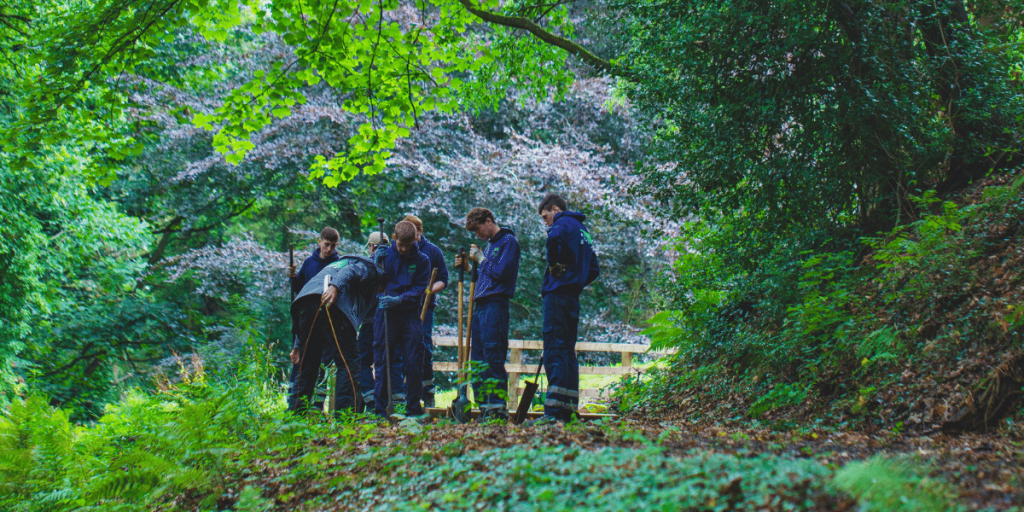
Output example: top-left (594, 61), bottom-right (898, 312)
top-left (614, 169), bottom-right (1024, 430)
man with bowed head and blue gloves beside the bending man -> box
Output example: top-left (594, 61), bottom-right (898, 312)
top-left (374, 220), bottom-right (430, 416)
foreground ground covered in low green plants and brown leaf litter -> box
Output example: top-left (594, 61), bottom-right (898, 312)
top-left (199, 411), bottom-right (1024, 510)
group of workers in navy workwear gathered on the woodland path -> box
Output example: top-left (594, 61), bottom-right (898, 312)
top-left (288, 194), bottom-right (600, 424)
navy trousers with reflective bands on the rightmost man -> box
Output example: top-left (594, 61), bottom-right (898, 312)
top-left (543, 293), bottom-right (580, 421)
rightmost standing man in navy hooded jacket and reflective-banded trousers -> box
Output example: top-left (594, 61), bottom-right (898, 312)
top-left (536, 194), bottom-right (600, 424)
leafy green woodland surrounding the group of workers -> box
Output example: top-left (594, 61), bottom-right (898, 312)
top-left (0, 0), bottom-right (1024, 510)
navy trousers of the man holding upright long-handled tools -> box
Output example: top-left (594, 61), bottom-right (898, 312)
top-left (470, 297), bottom-right (509, 417)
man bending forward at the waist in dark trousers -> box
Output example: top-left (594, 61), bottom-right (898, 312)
top-left (289, 251), bottom-right (385, 413)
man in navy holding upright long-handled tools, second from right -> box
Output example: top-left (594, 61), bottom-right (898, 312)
top-left (456, 208), bottom-right (520, 421)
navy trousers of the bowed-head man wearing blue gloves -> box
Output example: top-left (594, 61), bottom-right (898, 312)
top-left (374, 309), bottom-right (423, 416)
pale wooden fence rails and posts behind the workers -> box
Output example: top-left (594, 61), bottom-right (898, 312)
top-left (434, 336), bottom-right (675, 411)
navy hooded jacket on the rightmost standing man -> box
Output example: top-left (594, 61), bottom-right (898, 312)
top-left (541, 212), bottom-right (601, 296)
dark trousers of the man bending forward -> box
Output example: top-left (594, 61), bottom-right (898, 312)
top-left (289, 302), bottom-right (359, 412)
